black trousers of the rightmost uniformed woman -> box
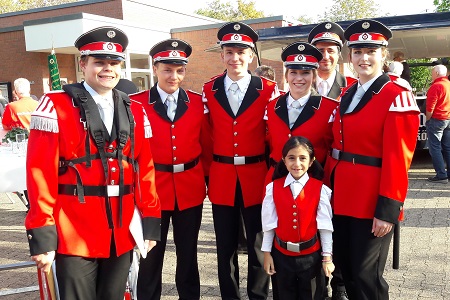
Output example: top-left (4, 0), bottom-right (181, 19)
top-left (333, 215), bottom-right (394, 300)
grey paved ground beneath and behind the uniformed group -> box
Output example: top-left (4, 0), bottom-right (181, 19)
top-left (0, 152), bottom-right (450, 300)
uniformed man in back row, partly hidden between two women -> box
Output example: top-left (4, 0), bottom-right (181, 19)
top-left (308, 22), bottom-right (356, 99)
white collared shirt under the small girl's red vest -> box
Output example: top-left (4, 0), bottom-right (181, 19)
top-left (261, 173), bottom-right (333, 253)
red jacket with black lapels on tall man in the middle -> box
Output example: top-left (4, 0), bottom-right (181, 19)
top-left (203, 74), bottom-right (278, 207)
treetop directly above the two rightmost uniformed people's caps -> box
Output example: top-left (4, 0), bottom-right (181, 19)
top-left (319, 0), bottom-right (378, 22)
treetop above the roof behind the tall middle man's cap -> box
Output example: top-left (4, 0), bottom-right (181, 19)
top-left (195, 0), bottom-right (264, 21)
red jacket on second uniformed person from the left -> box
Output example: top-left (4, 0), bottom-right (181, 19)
top-left (131, 85), bottom-right (206, 211)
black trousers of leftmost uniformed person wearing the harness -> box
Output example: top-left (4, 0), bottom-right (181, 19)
top-left (56, 239), bottom-right (133, 300)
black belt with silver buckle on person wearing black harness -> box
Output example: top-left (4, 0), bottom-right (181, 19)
top-left (58, 184), bottom-right (133, 197)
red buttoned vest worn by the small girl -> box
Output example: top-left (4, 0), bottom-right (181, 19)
top-left (273, 177), bottom-right (322, 256)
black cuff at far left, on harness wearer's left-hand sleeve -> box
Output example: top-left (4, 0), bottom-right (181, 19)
top-left (27, 225), bottom-right (58, 255)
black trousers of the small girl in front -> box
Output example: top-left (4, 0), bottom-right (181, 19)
top-left (271, 247), bottom-right (322, 300)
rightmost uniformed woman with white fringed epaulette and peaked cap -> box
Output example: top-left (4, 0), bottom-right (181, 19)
top-left (325, 20), bottom-right (420, 300)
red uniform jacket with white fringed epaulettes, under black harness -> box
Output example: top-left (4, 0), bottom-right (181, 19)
top-left (25, 90), bottom-right (161, 258)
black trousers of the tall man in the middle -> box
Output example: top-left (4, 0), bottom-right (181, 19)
top-left (212, 182), bottom-right (269, 300)
